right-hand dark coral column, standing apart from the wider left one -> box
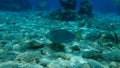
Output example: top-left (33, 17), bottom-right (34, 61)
top-left (78, 0), bottom-right (92, 16)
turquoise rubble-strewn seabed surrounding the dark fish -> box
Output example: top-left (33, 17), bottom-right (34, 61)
top-left (0, 11), bottom-right (120, 68)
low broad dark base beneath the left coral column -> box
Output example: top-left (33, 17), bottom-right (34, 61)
top-left (49, 9), bottom-right (76, 21)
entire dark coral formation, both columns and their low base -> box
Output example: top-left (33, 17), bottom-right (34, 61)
top-left (49, 0), bottom-right (93, 21)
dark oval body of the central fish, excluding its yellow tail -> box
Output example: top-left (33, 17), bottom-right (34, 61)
top-left (46, 29), bottom-right (75, 43)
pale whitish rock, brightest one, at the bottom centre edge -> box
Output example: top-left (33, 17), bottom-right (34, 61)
top-left (48, 56), bottom-right (88, 68)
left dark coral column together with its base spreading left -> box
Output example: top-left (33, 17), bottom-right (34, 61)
top-left (50, 0), bottom-right (76, 21)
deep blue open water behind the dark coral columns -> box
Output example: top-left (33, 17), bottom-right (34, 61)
top-left (30, 0), bottom-right (116, 13)
